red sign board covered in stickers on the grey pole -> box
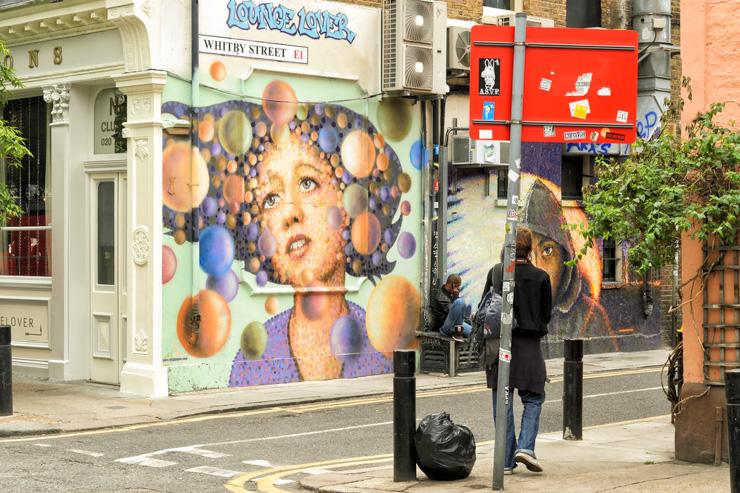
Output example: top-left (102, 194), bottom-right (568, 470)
top-left (470, 25), bottom-right (638, 144)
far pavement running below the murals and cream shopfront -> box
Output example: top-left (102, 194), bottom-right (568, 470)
top-left (0, 350), bottom-right (668, 437)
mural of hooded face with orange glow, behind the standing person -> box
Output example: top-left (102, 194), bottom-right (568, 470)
top-left (448, 143), bottom-right (660, 357)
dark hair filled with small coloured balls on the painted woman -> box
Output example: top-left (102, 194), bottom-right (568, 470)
top-left (162, 101), bottom-right (403, 283)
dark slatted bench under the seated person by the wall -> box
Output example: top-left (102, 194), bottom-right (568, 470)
top-left (416, 331), bottom-right (481, 377)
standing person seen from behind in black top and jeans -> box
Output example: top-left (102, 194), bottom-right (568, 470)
top-left (486, 227), bottom-right (552, 474)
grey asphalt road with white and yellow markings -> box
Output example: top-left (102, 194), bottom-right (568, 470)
top-left (0, 368), bottom-right (670, 493)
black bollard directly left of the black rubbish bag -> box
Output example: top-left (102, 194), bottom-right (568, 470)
top-left (393, 350), bottom-right (416, 481)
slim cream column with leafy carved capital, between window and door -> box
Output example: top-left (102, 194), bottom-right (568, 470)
top-left (44, 84), bottom-right (71, 380)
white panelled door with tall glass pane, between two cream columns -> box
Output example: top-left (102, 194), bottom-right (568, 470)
top-left (89, 173), bottom-right (126, 384)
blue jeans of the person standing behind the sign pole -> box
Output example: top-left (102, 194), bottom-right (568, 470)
top-left (492, 390), bottom-right (545, 468)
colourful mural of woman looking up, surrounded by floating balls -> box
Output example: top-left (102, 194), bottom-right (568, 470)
top-left (162, 80), bottom-right (421, 386)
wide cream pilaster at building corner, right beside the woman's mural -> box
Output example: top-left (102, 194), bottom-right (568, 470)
top-left (116, 70), bottom-right (168, 397)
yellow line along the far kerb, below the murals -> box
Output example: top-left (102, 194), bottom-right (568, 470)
top-left (0, 367), bottom-right (662, 443)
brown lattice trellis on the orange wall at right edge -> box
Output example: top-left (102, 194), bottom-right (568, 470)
top-left (703, 234), bottom-right (740, 385)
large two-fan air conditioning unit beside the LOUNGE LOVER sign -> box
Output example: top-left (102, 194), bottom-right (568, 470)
top-left (383, 0), bottom-right (447, 94)
